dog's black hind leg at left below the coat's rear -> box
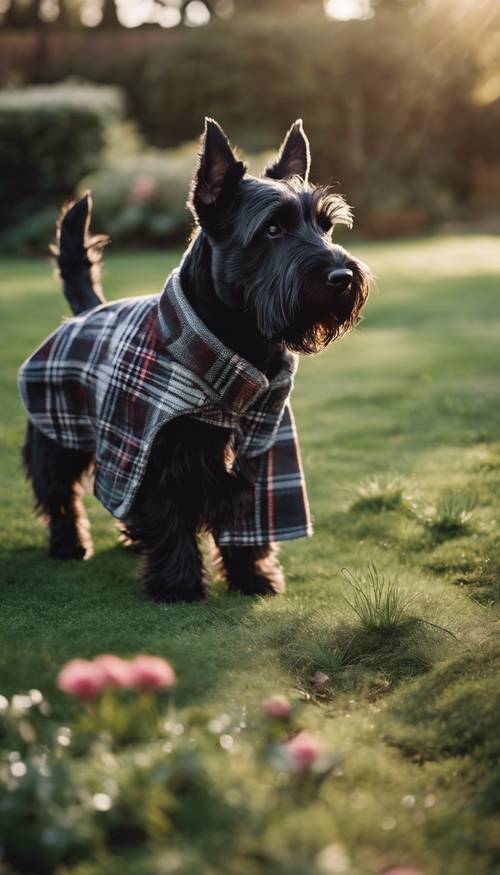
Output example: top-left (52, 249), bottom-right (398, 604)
top-left (22, 423), bottom-right (93, 559)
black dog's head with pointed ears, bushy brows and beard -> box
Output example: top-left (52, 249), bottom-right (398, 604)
top-left (188, 119), bottom-right (369, 353)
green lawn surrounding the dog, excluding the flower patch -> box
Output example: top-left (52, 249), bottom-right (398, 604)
top-left (0, 236), bottom-right (500, 875)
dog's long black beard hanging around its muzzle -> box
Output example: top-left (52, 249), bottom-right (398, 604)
top-left (247, 262), bottom-right (370, 355)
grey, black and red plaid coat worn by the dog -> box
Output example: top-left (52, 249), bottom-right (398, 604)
top-left (19, 269), bottom-right (312, 546)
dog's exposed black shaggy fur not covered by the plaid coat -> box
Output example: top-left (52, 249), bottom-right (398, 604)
top-left (23, 120), bottom-right (369, 601)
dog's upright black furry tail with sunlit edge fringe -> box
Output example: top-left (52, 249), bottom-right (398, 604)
top-left (51, 191), bottom-right (109, 316)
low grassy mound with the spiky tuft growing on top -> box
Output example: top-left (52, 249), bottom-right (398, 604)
top-left (270, 563), bottom-right (455, 704)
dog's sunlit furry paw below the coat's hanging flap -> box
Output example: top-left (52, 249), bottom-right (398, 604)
top-left (219, 544), bottom-right (286, 595)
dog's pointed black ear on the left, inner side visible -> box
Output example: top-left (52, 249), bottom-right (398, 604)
top-left (188, 118), bottom-right (246, 219)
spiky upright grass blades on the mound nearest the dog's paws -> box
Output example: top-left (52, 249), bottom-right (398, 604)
top-left (341, 562), bottom-right (414, 631)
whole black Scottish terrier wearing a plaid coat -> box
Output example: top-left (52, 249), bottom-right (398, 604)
top-left (20, 120), bottom-right (369, 601)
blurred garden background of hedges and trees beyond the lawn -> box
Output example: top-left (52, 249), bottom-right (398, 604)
top-left (0, 0), bottom-right (500, 250)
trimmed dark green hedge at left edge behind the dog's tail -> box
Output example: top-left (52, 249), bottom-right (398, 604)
top-left (0, 84), bottom-right (121, 247)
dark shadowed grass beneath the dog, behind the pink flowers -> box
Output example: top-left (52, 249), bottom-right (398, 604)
top-left (0, 545), bottom-right (254, 705)
